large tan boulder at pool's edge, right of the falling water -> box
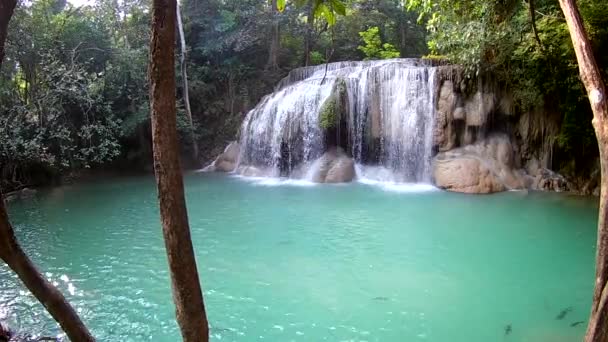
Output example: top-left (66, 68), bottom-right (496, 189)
top-left (433, 136), bottom-right (526, 194)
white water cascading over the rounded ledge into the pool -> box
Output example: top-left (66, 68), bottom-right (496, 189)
top-left (238, 59), bottom-right (436, 183)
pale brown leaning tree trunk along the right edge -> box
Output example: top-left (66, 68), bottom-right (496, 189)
top-left (559, 0), bottom-right (608, 342)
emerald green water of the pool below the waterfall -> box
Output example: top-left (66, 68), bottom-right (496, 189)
top-left (0, 174), bottom-right (597, 342)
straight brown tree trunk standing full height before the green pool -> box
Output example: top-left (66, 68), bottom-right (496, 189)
top-left (148, 0), bottom-right (209, 342)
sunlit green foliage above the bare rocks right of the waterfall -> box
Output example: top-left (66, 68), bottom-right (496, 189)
top-left (407, 0), bottom-right (608, 175)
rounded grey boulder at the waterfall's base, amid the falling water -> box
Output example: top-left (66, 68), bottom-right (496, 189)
top-left (312, 148), bottom-right (355, 183)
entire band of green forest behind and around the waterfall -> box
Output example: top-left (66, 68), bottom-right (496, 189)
top-left (0, 0), bottom-right (608, 190)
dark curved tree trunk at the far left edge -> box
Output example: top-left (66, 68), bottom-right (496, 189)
top-left (0, 0), bottom-right (95, 342)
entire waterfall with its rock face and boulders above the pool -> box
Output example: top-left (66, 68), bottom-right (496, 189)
top-left (208, 59), bottom-right (568, 193)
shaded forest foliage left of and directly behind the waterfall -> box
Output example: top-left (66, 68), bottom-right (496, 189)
top-left (0, 0), bottom-right (426, 190)
